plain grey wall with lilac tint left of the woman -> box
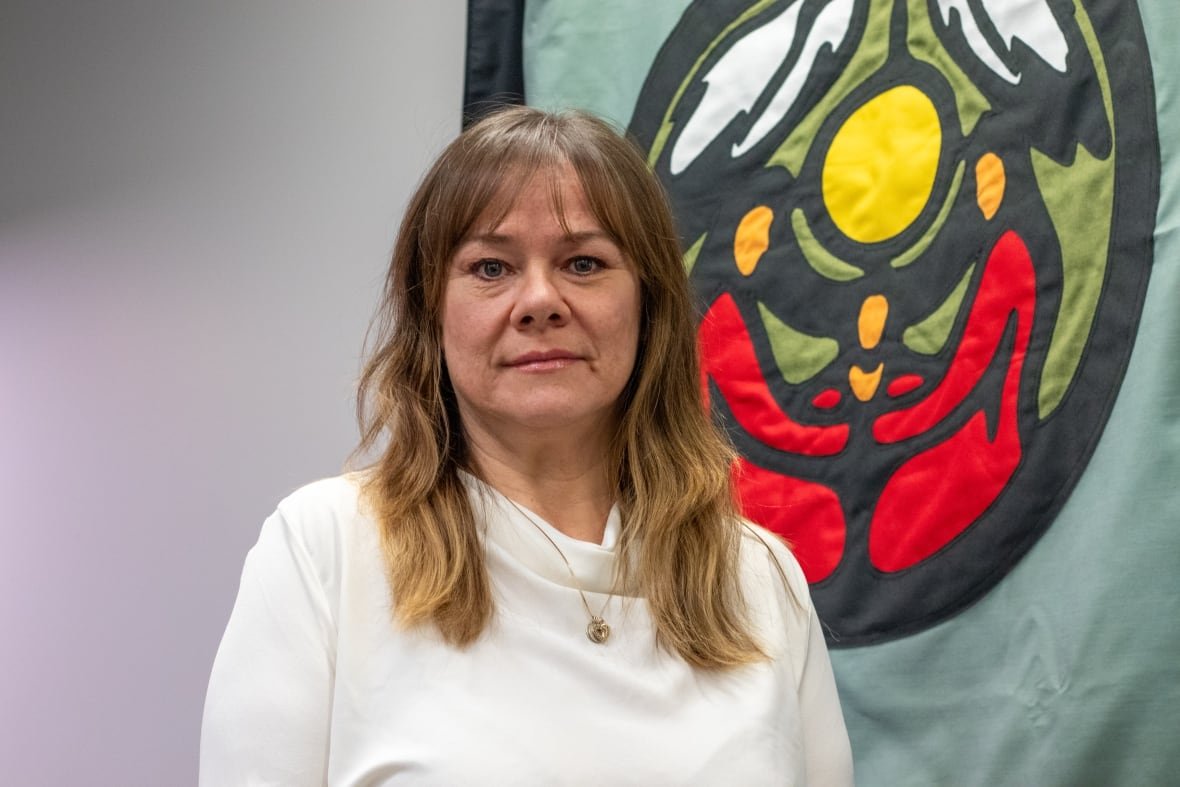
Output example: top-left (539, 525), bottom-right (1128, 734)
top-left (0, 0), bottom-right (465, 786)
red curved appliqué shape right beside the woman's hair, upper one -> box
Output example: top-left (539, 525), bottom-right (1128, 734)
top-left (696, 293), bottom-right (848, 457)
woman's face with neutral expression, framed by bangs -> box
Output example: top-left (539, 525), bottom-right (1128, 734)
top-left (443, 168), bottom-right (640, 434)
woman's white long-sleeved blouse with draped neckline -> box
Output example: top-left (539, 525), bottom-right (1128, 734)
top-left (201, 477), bottom-right (852, 787)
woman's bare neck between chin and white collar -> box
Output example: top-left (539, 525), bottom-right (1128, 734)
top-left (464, 424), bottom-right (616, 544)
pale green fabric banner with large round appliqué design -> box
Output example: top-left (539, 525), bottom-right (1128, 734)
top-left (479, 0), bottom-right (1180, 787)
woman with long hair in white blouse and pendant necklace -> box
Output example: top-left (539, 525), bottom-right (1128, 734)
top-left (201, 107), bottom-right (851, 786)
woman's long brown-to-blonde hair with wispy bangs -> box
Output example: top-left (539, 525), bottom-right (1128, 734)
top-left (356, 107), bottom-right (763, 669)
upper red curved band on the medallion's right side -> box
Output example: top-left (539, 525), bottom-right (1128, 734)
top-left (873, 230), bottom-right (1036, 444)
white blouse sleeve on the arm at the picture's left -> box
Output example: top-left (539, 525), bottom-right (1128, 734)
top-left (199, 512), bottom-right (336, 787)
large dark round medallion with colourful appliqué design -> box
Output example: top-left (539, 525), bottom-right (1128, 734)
top-left (630, 0), bottom-right (1160, 645)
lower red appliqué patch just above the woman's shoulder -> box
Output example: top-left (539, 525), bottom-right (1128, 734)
top-left (733, 459), bottom-right (846, 583)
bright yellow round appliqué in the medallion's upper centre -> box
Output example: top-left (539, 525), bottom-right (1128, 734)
top-left (824, 85), bottom-right (942, 243)
